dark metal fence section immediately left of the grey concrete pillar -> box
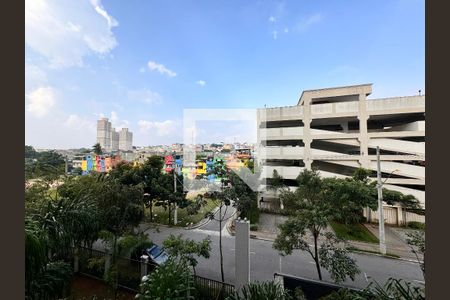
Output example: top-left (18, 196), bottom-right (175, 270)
top-left (194, 275), bottom-right (234, 300)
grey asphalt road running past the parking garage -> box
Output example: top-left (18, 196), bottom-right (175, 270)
top-left (142, 208), bottom-right (424, 288)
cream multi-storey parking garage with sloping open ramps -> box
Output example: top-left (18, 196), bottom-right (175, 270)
top-left (257, 84), bottom-right (425, 207)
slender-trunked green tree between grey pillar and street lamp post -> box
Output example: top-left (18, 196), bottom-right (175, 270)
top-left (273, 169), bottom-right (359, 282)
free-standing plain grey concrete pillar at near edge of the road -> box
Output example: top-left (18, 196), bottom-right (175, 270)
top-left (234, 218), bottom-right (250, 293)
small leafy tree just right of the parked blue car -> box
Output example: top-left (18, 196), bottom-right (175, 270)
top-left (163, 234), bottom-right (211, 274)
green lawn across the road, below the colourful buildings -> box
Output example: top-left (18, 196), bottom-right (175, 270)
top-left (145, 199), bottom-right (217, 227)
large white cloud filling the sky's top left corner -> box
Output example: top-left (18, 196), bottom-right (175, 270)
top-left (25, 0), bottom-right (118, 68)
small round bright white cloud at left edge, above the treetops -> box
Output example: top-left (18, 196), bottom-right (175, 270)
top-left (25, 86), bottom-right (56, 118)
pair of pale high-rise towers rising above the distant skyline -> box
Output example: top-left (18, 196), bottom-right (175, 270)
top-left (97, 118), bottom-right (133, 152)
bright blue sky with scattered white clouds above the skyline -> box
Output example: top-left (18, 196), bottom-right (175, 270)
top-left (25, 0), bottom-right (425, 148)
